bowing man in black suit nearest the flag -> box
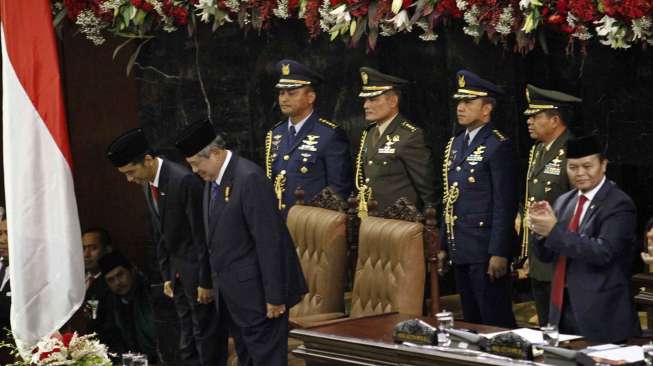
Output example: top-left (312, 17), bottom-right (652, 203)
top-left (107, 129), bottom-right (220, 366)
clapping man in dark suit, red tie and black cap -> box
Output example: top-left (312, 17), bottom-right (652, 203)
top-left (528, 136), bottom-right (640, 343)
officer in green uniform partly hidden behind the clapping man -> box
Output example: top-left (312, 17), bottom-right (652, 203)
top-left (521, 84), bottom-right (581, 325)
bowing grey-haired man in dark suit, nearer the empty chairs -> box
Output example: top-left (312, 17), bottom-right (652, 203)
top-left (177, 121), bottom-right (307, 366)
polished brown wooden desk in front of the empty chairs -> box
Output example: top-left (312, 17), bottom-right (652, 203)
top-left (290, 313), bottom-right (540, 366)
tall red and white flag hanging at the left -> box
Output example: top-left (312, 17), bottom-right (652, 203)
top-left (0, 0), bottom-right (84, 349)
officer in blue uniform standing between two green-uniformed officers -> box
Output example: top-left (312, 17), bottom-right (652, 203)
top-left (440, 70), bottom-right (518, 328)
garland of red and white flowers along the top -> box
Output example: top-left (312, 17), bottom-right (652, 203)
top-left (52, 0), bottom-right (653, 51)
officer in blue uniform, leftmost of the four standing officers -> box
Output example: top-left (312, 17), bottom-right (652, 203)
top-left (265, 60), bottom-right (354, 216)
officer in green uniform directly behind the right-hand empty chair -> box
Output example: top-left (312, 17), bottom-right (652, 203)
top-left (356, 67), bottom-right (436, 212)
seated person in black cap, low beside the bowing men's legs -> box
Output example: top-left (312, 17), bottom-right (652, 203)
top-left (98, 251), bottom-right (157, 362)
